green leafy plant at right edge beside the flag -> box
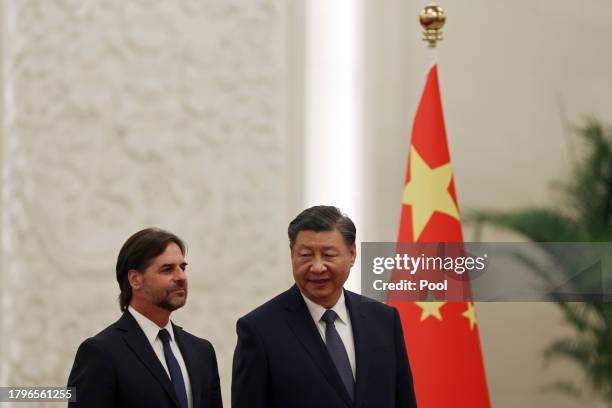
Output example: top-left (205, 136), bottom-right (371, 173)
top-left (468, 121), bottom-right (612, 406)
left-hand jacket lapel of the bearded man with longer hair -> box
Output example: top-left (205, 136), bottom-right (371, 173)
top-left (115, 312), bottom-right (179, 407)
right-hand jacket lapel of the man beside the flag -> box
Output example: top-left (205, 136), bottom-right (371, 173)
top-left (344, 291), bottom-right (370, 407)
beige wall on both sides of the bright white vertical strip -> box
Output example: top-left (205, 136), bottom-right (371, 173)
top-left (0, 0), bottom-right (612, 407)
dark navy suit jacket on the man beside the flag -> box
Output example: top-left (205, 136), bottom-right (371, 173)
top-left (232, 285), bottom-right (416, 408)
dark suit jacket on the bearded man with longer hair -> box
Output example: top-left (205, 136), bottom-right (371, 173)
top-left (68, 312), bottom-right (222, 408)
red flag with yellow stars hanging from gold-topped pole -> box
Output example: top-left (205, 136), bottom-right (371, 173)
top-left (389, 64), bottom-right (490, 408)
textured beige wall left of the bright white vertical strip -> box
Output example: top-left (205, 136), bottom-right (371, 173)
top-left (0, 0), bottom-right (295, 403)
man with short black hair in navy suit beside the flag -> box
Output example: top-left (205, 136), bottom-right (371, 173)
top-left (232, 206), bottom-right (416, 408)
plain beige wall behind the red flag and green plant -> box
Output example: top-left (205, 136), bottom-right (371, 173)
top-left (363, 0), bottom-right (612, 408)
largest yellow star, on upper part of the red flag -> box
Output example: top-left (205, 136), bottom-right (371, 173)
top-left (403, 146), bottom-right (459, 241)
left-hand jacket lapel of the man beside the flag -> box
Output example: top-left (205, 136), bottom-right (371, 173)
top-left (286, 285), bottom-right (353, 407)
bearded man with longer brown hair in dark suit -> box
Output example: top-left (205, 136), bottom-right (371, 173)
top-left (68, 228), bottom-right (222, 408)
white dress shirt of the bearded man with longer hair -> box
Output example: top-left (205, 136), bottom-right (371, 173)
top-left (128, 305), bottom-right (193, 408)
